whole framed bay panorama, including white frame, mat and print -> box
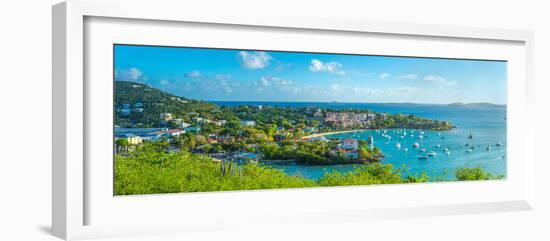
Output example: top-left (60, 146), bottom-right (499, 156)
top-left (52, 0), bottom-right (535, 239)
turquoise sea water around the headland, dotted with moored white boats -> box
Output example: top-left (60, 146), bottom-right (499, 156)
top-left (215, 102), bottom-right (506, 180)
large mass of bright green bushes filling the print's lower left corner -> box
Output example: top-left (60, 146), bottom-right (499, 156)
top-left (115, 144), bottom-right (315, 195)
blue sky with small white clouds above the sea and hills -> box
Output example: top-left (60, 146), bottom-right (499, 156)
top-left (114, 45), bottom-right (507, 104)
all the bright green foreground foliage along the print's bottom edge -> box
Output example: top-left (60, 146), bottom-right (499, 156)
top-left (115, 143), bottom-right (500, 195)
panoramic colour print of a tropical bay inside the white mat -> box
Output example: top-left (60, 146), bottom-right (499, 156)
top-left (113, 44), bottom-right (507, 195)
